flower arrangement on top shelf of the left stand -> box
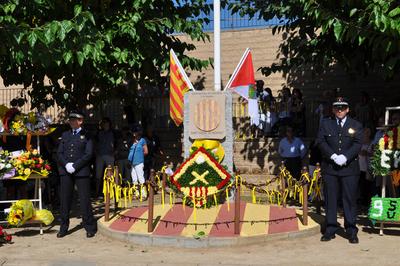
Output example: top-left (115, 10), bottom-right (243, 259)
top-left (0, 105), bottom-right (51, 135)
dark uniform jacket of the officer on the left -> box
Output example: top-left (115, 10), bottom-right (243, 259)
top-left (57, 129), bottom-right (93, 176)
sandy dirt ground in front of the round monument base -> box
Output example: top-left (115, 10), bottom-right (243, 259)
top-left (0, 201), bottom-right (400, 266)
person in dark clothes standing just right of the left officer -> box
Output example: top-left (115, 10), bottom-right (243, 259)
top-left (95, 117), bottom-right (115, 198)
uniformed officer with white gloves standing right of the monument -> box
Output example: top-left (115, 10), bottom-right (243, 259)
top-left (317, 97), bottom-right (362, 244)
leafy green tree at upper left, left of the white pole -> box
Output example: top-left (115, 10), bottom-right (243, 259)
top-left (0, 0), bottom-right (210, 109)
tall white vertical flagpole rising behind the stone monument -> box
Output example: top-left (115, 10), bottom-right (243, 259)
top-left (214, 0), bottom-right (221, 91)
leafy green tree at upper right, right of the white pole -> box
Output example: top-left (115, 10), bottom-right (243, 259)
top-left (228, 0), bottom-right (400, 78)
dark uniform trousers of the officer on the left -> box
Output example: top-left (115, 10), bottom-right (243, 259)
top-left (60, 175), bottom-right (97, 233)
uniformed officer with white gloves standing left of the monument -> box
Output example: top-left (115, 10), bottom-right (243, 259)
top-left (57, 111), bottom-right (97, 238)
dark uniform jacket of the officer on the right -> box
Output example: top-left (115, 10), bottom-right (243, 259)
top-left (317, 116), bottom-right (363, 176)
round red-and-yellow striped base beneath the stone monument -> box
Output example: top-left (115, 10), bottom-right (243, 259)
top-left (100, 202), bottom-right (317, 237)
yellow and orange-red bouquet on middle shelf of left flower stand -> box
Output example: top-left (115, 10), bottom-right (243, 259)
top-left (10, 150), bottom-right (51, 180)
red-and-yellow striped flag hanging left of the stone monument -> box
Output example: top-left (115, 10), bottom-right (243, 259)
top-left (169, 49), bottom-right (194, 126)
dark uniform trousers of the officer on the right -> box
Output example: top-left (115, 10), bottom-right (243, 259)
top-left (323, 175), bottom-right (359, 236)
